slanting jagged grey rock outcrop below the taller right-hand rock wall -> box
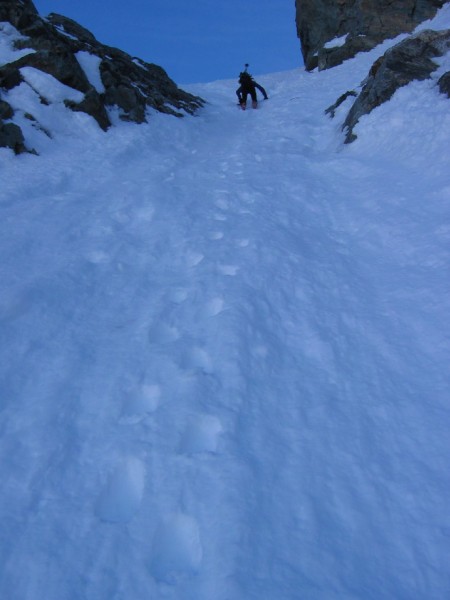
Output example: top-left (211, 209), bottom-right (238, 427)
top-left (328, 29), bottom-right (450, 143)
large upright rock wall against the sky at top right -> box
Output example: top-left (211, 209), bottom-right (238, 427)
top-left (296, 0), bottom-right (448, 70)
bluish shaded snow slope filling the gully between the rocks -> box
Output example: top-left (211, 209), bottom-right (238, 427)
top-left (0, 11), bottom-right (450, 600)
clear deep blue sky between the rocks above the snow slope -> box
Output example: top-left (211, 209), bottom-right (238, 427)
top-left (34, 0), bottom-right (303, 83)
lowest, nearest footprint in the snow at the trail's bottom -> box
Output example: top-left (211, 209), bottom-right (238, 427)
top-left (150, 513), bottom-right (203, 585)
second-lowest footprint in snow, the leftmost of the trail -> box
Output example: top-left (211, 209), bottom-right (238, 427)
top-left (95, 457), bottom-right (145, 523)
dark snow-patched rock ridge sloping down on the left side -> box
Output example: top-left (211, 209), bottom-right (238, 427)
top-left (0, 0), bottom-right (204, 151)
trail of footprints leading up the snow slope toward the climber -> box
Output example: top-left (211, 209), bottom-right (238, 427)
top-left (95, 196), bottom-right (248, 585)
